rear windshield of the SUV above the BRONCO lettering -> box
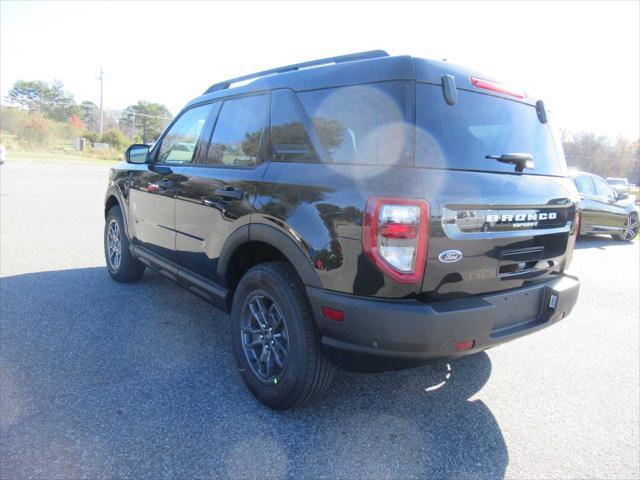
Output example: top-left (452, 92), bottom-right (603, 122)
top-left (416, 83), bottom-right (566, 176)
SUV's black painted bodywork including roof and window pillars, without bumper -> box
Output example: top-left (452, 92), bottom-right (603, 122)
top-left (107, 52), bottom-right (578, 356)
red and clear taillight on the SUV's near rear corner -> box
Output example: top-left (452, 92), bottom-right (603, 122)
top-left (362, 197), bottom-right (429, 283)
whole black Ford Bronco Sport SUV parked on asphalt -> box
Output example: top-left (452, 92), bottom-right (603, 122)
top-left (104, 51), bottom-right (579, 409)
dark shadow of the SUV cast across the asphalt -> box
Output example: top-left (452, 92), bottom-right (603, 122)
top-left (0, 268), bottom-right (508, 478)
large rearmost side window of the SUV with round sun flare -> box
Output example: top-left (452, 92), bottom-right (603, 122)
top-left (298, 81), bottom-right (413, 165)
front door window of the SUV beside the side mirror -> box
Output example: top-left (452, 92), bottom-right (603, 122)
top-left (157, 105), bottom-right (211, 165)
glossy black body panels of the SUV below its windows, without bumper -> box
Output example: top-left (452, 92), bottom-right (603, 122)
top-left (112, 156), bottom-right (575, 300)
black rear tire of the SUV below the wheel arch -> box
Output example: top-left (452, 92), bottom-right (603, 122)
top-left (231, 262), bottom-right (335, 410)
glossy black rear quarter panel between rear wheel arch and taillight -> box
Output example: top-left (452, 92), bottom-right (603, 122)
top-left (252, 162), bottom-right (423, 298)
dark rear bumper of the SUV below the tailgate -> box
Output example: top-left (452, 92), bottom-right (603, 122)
top-left (307, 275), bottom-right (580, 360)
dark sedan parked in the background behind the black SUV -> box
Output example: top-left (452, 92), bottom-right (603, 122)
top-left (571, 171), bottom-right (638, 241)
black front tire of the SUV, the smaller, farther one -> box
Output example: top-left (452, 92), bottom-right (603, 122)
top-left (104, 206), bottom-right (144, 283)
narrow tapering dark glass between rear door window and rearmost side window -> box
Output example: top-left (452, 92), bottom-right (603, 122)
top-left (271, 91), bottom-right (320, 163)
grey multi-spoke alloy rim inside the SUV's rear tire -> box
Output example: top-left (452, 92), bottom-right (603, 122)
top-left (241, 292), bottom-right (289, 384)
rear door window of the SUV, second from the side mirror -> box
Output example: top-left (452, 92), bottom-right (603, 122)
top-left (207, 95), bottom-right (269, 167)
